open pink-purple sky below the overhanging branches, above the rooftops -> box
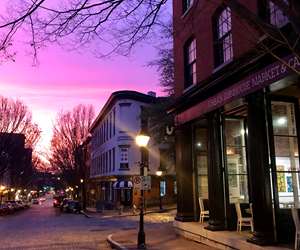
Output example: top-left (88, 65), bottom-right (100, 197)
top-left (0, 43), bottom-right (161, 150)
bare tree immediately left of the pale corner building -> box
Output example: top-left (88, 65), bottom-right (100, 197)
top-left (49, 104), bottom-right (94, 184)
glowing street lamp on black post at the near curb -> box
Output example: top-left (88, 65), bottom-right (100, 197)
top-left (135, 133), bottom-right (150, 249)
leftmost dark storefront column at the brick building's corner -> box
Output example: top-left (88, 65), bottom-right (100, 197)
top-left (175, 122), bottom-right (196, 221)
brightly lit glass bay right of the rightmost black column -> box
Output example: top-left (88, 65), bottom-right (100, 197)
top-left (269, 95), bottom-right (300, 242)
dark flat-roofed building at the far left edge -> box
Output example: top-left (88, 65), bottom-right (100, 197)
top-left (0, 133), bottom-right (33, 188)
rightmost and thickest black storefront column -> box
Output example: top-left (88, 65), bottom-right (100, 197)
top-left (247, 91), bottom-right (274, 245)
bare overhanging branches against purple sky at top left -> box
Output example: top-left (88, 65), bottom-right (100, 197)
top-left (0, 0), bottom-right (167, 61)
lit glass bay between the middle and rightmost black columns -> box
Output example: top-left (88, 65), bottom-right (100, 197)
top-left (223, 112), bottom-right (250, 230)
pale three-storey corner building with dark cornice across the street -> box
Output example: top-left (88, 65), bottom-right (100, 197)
top-left (88, 91), bottom-right (176, 210)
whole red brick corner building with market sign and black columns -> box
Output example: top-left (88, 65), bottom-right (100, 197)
top-left (170, 0), bottom-right (300, 245)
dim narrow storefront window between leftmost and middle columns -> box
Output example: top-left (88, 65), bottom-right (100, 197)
top-left (194, 128), bottom-right (208, 199)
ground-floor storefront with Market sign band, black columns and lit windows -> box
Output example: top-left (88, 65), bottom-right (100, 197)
top-left (174, 56), bottom-right (300, 245)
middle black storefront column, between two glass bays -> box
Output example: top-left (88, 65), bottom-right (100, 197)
top-left (206, 110), bottom-right (225, 231)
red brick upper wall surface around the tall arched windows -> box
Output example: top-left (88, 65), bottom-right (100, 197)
top-left (173, 0), bottom-right (258, 96)
